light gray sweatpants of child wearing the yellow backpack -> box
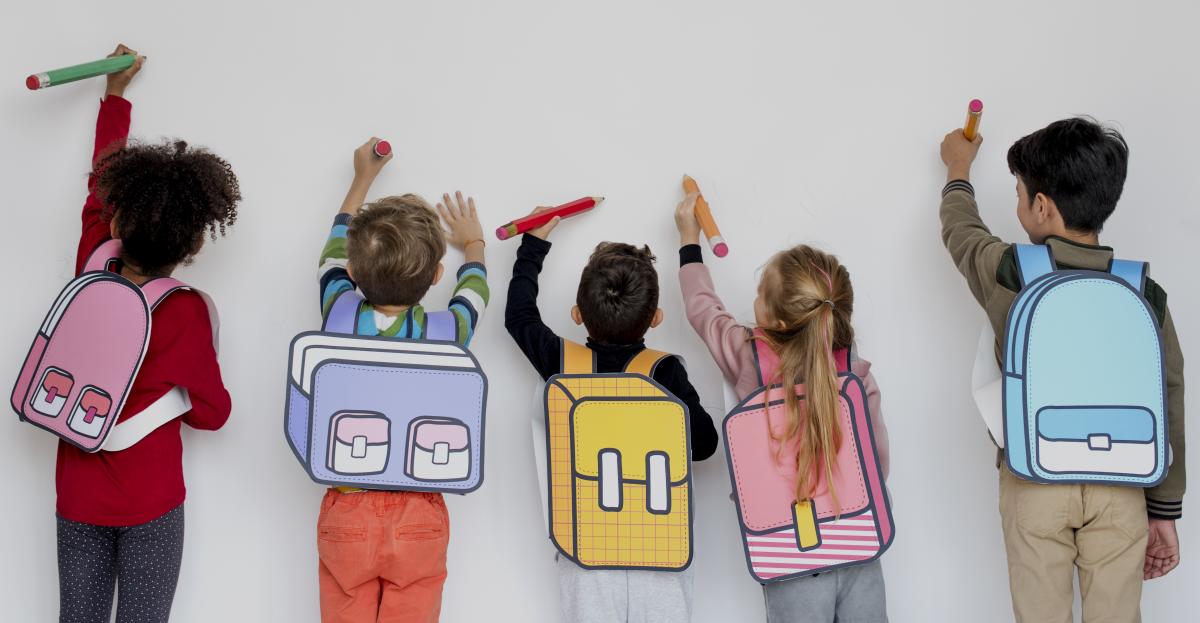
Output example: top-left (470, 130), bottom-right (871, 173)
top-left (556, 555), bottom-right (694, 623)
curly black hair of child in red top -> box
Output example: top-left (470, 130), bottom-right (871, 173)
top-left (91, 140), bottom-right (241, 276)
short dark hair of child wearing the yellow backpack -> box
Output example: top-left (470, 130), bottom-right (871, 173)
top-left (575, 242), bottom-right (659, 345)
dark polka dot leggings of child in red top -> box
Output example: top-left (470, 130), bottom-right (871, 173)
top-left (58, 504), bottom-right (184, 623)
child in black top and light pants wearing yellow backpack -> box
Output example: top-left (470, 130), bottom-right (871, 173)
top-left (504, 210), bottom-right (716, 623)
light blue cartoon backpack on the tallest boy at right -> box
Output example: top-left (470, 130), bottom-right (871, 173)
top-left (1003, 245), bottom-right (1169, 487)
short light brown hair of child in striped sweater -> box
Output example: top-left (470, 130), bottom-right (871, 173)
top-left (346, 193), bottom-right (446, 305)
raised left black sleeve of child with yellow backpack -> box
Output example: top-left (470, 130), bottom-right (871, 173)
top-left (504, 234), bottom-right (563, 379)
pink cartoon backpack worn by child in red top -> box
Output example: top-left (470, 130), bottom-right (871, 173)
top-left (12, 240), bottom-right (218, 453)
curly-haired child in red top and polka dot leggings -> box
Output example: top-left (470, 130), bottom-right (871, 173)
top-left (56, 46), bottom-right (241, 622)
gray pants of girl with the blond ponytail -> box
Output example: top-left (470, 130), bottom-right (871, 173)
top-left (762, 561), bottom-right (888, 623)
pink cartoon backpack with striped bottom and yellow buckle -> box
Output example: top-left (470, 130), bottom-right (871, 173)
top-left (724, 331), bottom-right (894, 583)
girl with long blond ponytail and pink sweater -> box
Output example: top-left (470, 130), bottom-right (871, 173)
top-left (676, 193), bottom-right (888, 623)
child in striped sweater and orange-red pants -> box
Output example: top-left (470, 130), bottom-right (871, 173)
top-left (317, 138), bottom-right (488, 623)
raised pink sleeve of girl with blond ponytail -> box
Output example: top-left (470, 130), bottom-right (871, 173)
top-left (679, 262), bottom-right (754, 384)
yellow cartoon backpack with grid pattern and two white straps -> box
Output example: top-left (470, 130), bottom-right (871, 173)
top-left (545, 340), bottom-right (692, 571)
